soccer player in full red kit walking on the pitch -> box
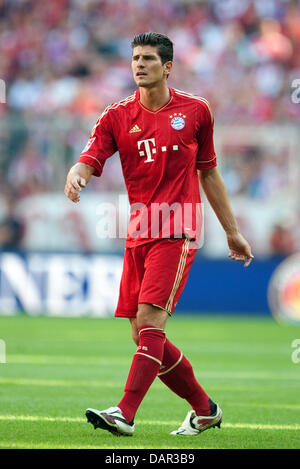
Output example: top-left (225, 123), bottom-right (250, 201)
top-left (65, 32), bottom-right (253, 435)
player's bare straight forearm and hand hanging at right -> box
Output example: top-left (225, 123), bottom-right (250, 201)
top-left (199, 166), bottom-right (254, 267)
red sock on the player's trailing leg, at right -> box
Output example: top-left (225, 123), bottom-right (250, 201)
top-left (158, 339), bottom-right (211, 415)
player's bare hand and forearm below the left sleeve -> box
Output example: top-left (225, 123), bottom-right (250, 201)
top-left (64, 163), bottom-right (95, 202)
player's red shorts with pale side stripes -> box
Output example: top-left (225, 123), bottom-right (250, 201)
top-left (115, 238), bottom-right (197, 318)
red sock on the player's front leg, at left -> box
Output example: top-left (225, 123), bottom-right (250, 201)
top-left (118, 326), bottom-right (165, 422)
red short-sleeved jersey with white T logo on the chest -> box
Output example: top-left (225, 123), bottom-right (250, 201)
top-left (78, 88), bottom-right (216, 247)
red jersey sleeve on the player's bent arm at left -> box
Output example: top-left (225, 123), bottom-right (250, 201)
top-left (78, 109), bottom-right (117, 176)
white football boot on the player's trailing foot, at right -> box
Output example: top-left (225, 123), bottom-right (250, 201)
top-left (171, 404), bottom-right (222, 435)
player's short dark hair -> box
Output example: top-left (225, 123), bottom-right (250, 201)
top-left (131, 32), bottom-right (173, 64)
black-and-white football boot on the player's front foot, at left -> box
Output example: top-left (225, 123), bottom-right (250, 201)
top-left (85, 407), bottom-right (134, 436)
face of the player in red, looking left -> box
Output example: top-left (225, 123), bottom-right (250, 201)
top-left (131, 46), bottom-right (172, 88)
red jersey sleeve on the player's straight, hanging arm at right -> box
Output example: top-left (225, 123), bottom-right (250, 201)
top-left (196, 100), bottom-right (217, 170)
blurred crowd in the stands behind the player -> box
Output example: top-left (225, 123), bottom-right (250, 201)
top-left (0, 0), bottom-right (300, 254)
